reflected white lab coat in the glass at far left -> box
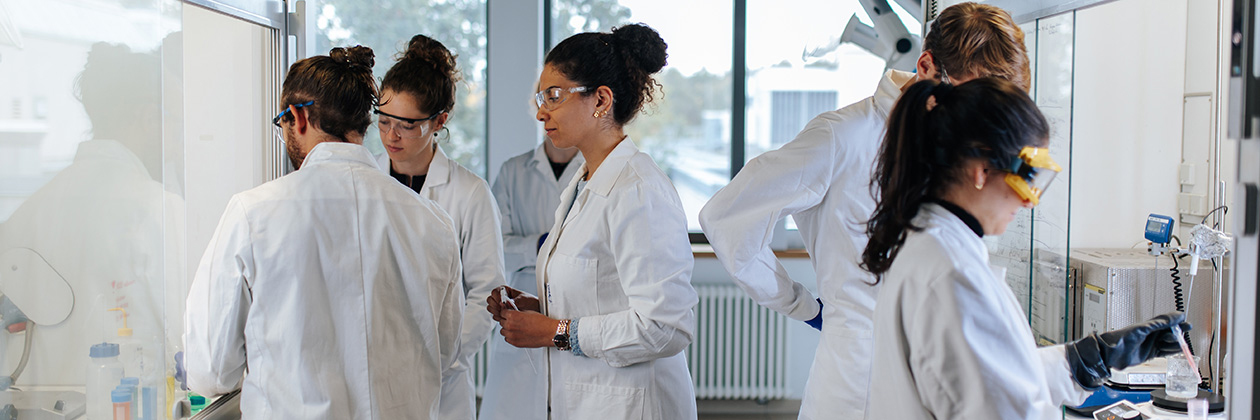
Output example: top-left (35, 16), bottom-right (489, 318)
top-left (0, 140), bottom-right (185, 386)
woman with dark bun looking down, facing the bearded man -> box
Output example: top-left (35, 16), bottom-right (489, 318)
top-left (374, 35), bottom-right (504, 420)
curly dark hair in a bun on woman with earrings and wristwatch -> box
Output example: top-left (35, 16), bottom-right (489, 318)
top-left (546, 24), bottom-right (669, 125)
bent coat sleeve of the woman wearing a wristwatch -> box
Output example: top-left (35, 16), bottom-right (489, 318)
top-left (577, 181), bottom-right (697, 367)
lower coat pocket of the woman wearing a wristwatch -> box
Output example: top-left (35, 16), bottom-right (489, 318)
top-left (564, 383), bottom-right (646, 420)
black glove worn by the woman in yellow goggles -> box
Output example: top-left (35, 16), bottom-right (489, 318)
top-left (1065, 312), bottom-right (1191, 390)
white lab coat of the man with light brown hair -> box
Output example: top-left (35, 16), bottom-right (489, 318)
top-left (699, 71), bottom-right (914, 419)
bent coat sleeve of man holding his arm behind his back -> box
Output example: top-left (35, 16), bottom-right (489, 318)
top-left (699, 120), bottom-right (838, 320)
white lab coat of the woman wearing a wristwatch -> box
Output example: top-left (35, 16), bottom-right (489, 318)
top-left (538, 139), bottom-right (697, 420)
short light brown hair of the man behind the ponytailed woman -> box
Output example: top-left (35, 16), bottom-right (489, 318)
top-left (924, 3), bottom-right (1032, 91)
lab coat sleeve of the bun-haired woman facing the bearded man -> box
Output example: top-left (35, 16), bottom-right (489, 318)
top-left (460, 180), bottom-right (505, 363)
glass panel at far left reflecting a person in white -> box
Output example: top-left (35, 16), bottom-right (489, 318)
top-left (0, 0), bottom-right (183, 417)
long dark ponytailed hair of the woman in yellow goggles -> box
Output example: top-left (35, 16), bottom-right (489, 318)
top-left (862, 77), bottom-right (1050, 277)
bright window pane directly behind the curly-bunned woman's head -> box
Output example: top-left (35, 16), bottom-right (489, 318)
top-left (552, 0), bottom-right (733, 232)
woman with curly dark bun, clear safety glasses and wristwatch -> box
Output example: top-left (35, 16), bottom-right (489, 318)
top-left (488, 24), bottom-right (697, 420)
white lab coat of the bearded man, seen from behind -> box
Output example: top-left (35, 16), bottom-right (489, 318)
top-left (185, 143), bottom-right (464, 419)
